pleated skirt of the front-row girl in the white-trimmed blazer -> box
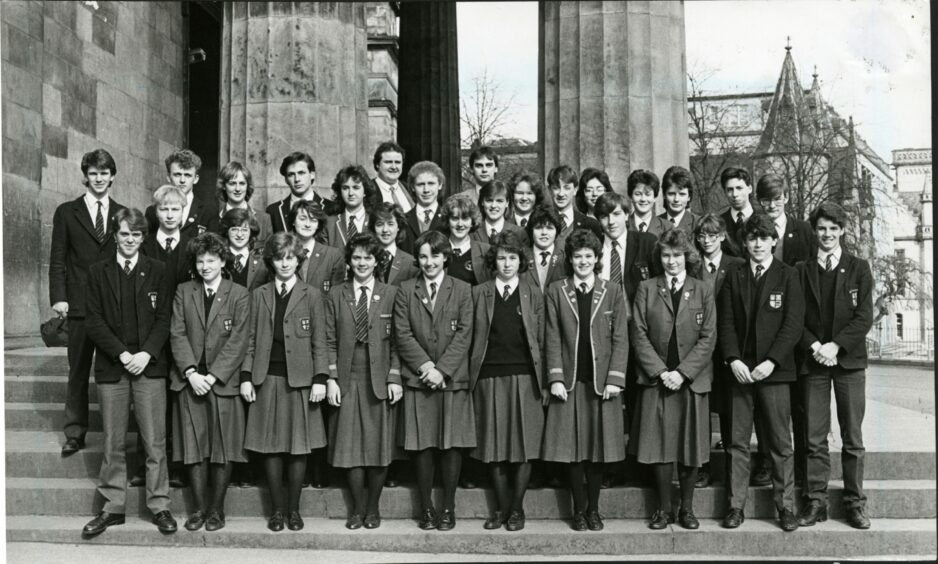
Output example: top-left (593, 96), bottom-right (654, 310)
top-left (541, 381), bottom-right (625, 462)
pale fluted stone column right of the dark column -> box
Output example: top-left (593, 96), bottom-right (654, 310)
top-left (538, 1), bottom-right (689, 193)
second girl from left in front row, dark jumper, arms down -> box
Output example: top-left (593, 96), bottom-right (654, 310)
top-left (241, 233), bottom-right (329, 531)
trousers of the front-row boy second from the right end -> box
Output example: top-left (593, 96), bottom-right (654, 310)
top-left (727, 382), bottom-right (795, 510)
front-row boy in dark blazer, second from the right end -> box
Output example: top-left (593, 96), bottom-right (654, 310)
top-left (718, 214), bottom-right (804, 531)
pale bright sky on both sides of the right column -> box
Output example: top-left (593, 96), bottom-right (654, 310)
top-left (457, 0), bottom-right (931, 162)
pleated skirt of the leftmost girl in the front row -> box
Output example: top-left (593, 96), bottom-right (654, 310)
top-left (172, 386), bottom-right (248, 464)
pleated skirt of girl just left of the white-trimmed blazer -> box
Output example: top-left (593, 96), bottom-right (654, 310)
top-left (469, 374), bottom-right (544, 462)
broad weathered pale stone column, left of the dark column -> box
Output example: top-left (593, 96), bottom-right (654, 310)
top-left (219, 2), bottom-right (370, 209)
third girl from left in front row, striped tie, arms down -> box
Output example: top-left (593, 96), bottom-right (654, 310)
top-left (326, 233), bottom-right (403, 529)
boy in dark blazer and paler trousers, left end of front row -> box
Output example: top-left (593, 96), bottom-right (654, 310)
top-left (82, 209), bottom-right (176, 537)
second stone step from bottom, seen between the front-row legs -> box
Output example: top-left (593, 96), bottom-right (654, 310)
top-left (6, 478), bottom-right (936, 519)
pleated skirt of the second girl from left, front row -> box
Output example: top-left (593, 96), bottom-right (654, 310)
top-left (244, 375), bottom-right (326, 454)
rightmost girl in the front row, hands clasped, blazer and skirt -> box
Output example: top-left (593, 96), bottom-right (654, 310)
top-left (629, 229), bottom-right (716, 529)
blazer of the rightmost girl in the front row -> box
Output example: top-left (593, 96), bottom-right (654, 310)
top-left (631, 275), bottom-right (717, 394)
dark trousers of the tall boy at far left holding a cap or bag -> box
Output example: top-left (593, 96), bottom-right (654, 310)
top-left (64, 317), bottom-right (94, 440)
